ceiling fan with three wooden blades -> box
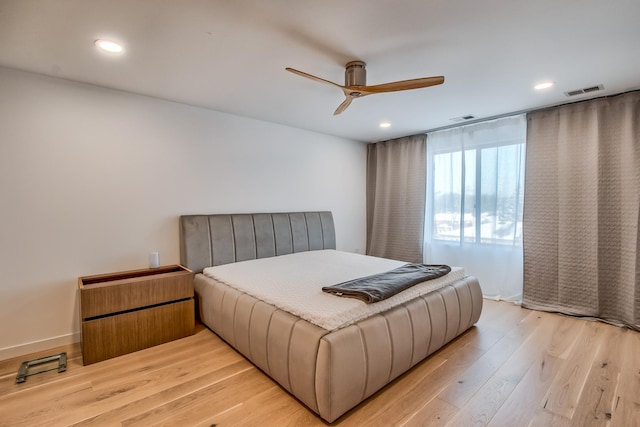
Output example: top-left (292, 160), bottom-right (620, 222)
top-left (286, 61), bottom-right (444, 116)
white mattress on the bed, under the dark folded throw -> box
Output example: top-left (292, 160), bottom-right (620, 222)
top-left (203, 249), bottom-right (464, 331)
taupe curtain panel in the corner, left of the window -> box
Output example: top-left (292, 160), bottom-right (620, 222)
top-left (367, 134), bottom-right (427, 263)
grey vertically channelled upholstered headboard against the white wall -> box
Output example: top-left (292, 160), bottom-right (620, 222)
top-left (180, 212), bottom-right (336, 273)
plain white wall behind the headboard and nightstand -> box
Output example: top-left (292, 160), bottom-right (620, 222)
top-left (0, 68), bottom-right (366, 359)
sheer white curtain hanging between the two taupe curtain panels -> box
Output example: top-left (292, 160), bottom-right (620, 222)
top-left (424, 115), bottom-right (527, 302)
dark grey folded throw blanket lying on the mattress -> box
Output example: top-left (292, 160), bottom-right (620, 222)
top-left (322, 264), bottom-right (451, 304)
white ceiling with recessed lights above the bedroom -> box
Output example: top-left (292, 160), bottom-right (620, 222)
top-left (0, 0), bottom-right (640, 141)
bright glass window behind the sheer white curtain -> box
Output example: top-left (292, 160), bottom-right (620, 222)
top-left (430, 140), bottom-right (524, 245)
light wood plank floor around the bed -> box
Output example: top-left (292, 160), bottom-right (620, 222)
top-left (0, 301), bottom-right (640, 427)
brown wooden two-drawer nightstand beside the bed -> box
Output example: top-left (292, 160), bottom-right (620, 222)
top-left (78, 265), bottom-right (195, 365)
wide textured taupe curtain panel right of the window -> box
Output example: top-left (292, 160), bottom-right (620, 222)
top-left (523, 92), bottom-right (640, 330)
